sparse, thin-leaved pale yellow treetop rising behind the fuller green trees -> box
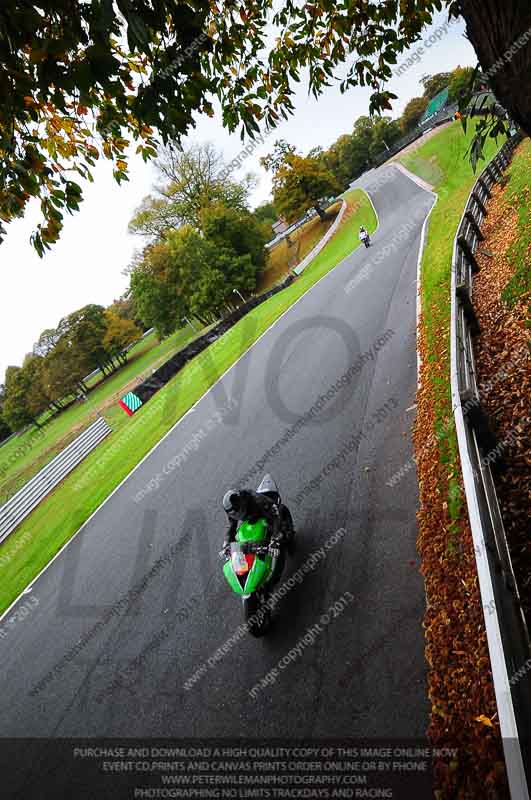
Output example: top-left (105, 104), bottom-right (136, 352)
top-left (129, 143), bottom-right (254, 239)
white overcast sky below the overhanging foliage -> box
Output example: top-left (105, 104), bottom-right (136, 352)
top-left (0, 14), bottom-right (477, 383)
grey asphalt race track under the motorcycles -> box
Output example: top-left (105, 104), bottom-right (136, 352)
top-left (0, 167), bottom-right (432, 796)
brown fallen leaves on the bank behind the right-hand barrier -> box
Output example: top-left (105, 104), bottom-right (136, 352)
top-left (474, 142), bottom-right (531, 627)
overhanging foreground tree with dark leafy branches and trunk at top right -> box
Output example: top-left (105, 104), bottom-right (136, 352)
top-left (0, 0), bottom-right (531, 254)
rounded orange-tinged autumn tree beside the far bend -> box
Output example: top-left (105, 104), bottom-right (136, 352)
top-left (273, 148), bottom-right (340, 222)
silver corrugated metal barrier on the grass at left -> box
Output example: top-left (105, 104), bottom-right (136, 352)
top-left (0, 417), bottom-right (111, 543)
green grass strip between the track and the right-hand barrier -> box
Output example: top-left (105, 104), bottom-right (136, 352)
top-left (400, 122), bottom-right (503, 530)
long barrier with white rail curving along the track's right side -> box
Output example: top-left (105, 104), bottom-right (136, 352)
top-left (451, 128), bottom-right (531, 800)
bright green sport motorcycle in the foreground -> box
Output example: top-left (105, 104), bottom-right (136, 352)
top-left (223, 475), bottom-right (295, 636)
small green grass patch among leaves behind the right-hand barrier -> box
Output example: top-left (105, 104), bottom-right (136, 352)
top-left (501, 139), bottom-right (531, 306)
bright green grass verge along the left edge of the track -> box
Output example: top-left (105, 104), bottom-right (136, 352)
top-left (0, 189), bottom-right (376, 610)
